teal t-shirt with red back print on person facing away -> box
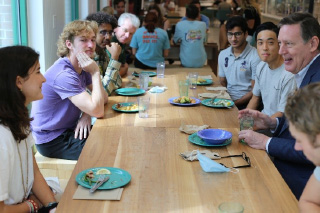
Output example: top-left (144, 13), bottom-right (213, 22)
top-left (130, 27), bottom-right (170, 68)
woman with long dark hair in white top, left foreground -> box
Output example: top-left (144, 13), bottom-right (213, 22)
top-left (0, 46), bottom-right (57, 212)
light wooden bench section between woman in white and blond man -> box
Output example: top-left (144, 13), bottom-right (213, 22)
top-left (35, 152), bottom-right (77, 180)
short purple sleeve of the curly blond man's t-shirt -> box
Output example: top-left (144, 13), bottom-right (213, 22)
top-left (53, 70), bottom-right (87, 99)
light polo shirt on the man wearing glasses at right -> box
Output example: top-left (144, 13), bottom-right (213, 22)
top-left (218, 43), bottom-right (260, 101)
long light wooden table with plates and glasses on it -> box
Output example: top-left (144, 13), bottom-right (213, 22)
top-left (57, 67), bottom-right (298, 212)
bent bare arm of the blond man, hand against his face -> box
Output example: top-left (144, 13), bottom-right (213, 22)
top-left (69, 53), bottom-right (105, 117)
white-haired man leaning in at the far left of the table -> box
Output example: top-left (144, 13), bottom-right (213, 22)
top-left (111, 13), bottom-right (140, 77)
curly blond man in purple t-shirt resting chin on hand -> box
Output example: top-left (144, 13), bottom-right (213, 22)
top-left (31, 20), bottom-right (108, 160)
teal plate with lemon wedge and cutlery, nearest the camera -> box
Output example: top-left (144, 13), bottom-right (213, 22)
top-left (76, 167), bottom-right (131, 190)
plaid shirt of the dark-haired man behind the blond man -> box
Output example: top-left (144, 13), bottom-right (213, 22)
top-left (94, 50), bottom-right (122, 95)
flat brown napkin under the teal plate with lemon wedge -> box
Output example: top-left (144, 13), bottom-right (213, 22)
top-left (72, 185), bottom-right (123, 200)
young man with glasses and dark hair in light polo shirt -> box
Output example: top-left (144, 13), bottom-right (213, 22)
top-left (218, 16), bottom-right (260, 109)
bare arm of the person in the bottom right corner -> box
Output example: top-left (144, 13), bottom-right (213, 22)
top-left (299, 174), bottom-right (320, 212)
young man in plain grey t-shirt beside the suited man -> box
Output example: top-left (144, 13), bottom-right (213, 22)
top-left (247, 22), bottom-right (296, 118)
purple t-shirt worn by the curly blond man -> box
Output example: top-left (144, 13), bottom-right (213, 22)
top-left (31, 57), bottom-right (92, 144)
